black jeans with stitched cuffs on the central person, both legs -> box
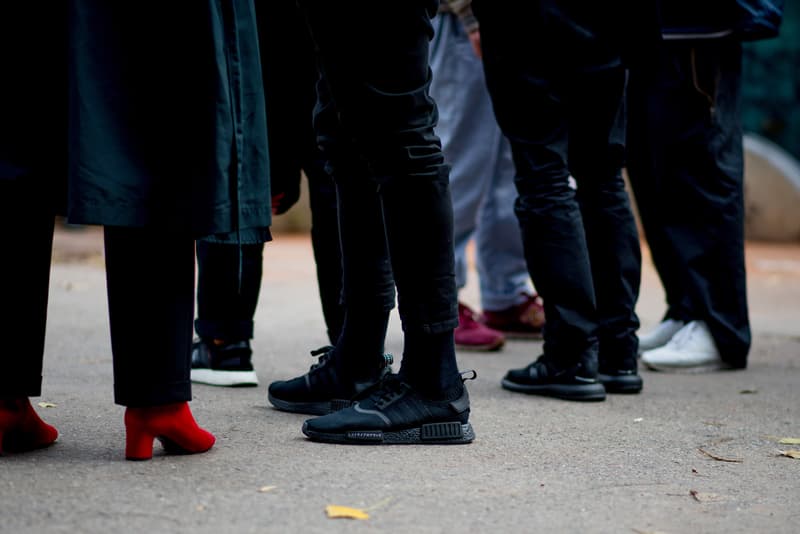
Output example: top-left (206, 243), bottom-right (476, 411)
top-left (298, 0), bottom-right (458, 333)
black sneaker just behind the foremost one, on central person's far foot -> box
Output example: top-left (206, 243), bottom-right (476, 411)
top-left (267, 346), bottom-right (393, 415)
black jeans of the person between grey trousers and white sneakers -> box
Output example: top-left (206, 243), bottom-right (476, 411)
top-left (474, 1), bottom-right (641, 368)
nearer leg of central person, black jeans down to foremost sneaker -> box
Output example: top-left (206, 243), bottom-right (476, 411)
top-left (292, 1), bottom-right (473, 443)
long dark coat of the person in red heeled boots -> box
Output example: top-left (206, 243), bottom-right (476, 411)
top-left (0, 0), bottom-right (271, 242)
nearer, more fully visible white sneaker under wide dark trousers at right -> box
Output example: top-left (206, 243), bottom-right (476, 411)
top-left (642, 321), bottom-right (726, 373)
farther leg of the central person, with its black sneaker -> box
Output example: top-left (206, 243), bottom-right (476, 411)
top-left (268, 78), bottom-right (395, 415)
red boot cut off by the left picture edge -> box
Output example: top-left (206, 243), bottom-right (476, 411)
top-left (0, 397), bottom-right (58, 454)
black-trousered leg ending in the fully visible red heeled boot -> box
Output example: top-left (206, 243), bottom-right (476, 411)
top-left (105, 227), bottom-right (214, 460)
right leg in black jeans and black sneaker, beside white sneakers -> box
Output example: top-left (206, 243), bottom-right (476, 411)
top-left (569, 68), bottom-right (642, 393)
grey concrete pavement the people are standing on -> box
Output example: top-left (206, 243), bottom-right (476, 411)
top-left (0, 229), bottom-right (800, 534)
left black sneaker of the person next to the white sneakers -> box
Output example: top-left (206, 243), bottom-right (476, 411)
top-left (502, 356), bottom-right (606, 401)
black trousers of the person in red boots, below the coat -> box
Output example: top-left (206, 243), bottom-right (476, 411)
top-left (0, 176), bottom-right (194, 406)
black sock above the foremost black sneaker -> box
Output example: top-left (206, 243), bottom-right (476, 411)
top-left (399, 330), bottom-right (463, 400)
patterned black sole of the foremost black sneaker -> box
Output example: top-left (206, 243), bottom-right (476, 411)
top-left (303, 421), bottom-right (475, 445)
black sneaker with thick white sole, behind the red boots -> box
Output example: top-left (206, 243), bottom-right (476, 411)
top-left (191, 339), bottom-right (258, 387)
